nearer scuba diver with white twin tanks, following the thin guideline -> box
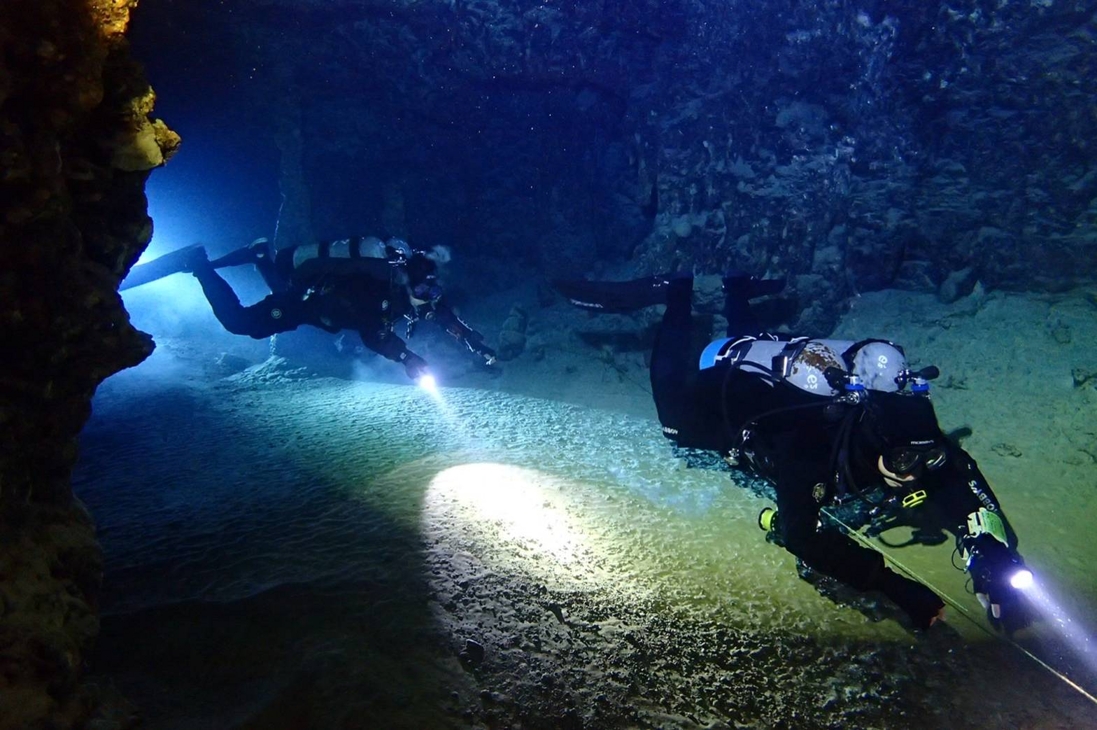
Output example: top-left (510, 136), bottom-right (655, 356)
top-left (556, 276), bottom-right (1031, 628)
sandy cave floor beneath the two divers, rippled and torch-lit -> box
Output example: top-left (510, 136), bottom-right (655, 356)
top-left (76, 281), bottom-right (1097, 729)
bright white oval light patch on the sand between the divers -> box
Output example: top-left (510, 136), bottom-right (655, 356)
top-left (426, 463), bottom-right (587, 564)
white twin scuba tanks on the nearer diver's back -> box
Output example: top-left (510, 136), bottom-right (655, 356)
top-left (700, 337), bottom-right (907, 396)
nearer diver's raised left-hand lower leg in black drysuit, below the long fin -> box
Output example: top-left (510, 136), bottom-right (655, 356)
top-left (651, 277), bottom-right (695, 438)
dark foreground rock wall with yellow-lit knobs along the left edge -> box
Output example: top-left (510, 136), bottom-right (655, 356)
top-left (0, 0), bottom-right (179, 729)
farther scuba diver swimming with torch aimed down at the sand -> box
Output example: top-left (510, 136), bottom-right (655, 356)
top-left (180, 237), bottom-right (495, 381)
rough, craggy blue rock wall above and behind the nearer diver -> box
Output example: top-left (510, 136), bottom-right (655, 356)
top-left (631, 0), bottom-right (1097, 332)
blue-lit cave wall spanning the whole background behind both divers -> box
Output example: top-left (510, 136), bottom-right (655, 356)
top-left (201, 0), bottom-right (1097, 332)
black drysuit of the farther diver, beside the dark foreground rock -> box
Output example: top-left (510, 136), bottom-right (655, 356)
top-left (192, 238), bottom-right (495, 377)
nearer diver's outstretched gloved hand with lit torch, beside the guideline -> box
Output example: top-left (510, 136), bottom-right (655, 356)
top-left (962, 535), bottom-right (1032, 629)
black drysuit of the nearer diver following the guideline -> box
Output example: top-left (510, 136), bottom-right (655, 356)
top-left (640, 279), bottom-right (1016, 624)
